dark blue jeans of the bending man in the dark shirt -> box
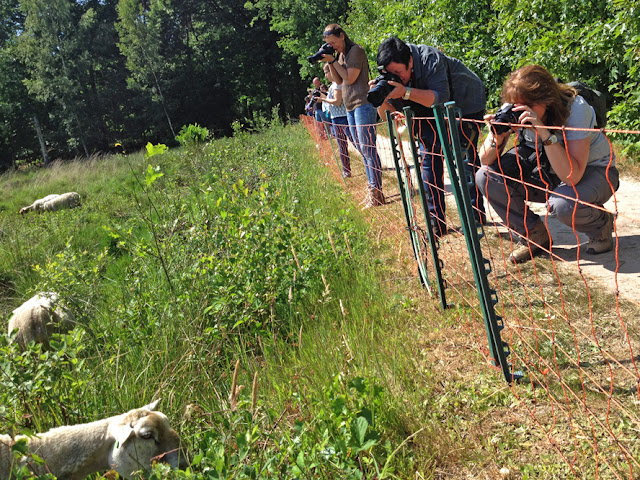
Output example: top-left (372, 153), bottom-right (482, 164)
top-left (420, 112), bottom-right (486, 234)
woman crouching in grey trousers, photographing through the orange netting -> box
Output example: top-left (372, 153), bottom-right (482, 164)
top-left (476, 65), bottom-right (619, 263)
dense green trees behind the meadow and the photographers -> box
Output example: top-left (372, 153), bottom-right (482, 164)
top-left (0, 0), bottom-right (640, 168)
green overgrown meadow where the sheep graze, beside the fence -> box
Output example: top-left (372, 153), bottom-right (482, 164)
top-left (0, 126), bottom-right (566, 478)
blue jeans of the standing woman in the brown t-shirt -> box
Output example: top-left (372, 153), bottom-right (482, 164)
top-left (347, 103), bottom-right (382, 190)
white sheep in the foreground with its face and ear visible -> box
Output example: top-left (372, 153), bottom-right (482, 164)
top-left (0, 400), bottom-right (188, 480)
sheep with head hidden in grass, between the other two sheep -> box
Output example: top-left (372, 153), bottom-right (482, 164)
top-left (7, 292), bottom-right (76, 348)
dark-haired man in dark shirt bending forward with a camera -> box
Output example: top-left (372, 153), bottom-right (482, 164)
top-left (377, 37), bottom-right (487, 235)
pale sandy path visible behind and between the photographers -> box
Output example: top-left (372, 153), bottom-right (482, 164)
top-left (378, 137), bottom-right (640, 303)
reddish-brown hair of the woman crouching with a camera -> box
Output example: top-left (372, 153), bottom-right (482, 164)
top-left (502, 65), bottom-right (578, 127)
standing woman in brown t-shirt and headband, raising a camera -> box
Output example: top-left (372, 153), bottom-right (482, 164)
top-left (321, 23), bottom-right (385, 208)
